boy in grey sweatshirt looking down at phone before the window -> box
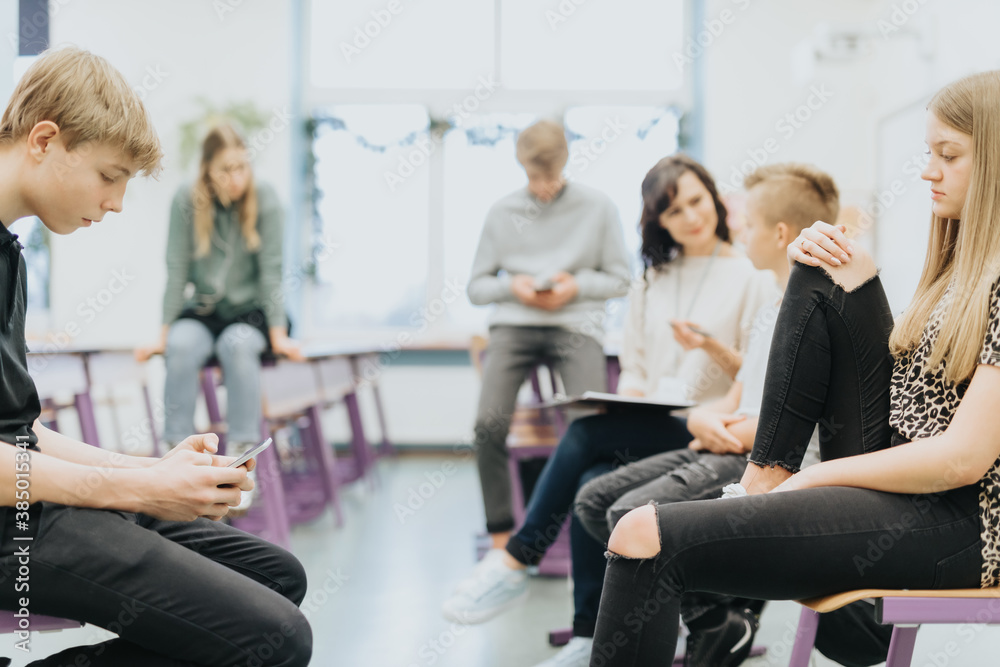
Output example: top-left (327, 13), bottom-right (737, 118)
top-left (468, 121), bottom-right (630, 549)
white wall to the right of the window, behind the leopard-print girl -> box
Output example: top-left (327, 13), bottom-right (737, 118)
top-left (704, 0), bottom-right (1000, 312)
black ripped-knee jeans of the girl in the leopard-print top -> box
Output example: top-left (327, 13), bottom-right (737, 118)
top-left (591, 265), bottom-right (982, 666)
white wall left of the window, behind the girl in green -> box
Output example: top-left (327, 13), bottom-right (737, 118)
top-left (49, 0), bottom-right (292, 347)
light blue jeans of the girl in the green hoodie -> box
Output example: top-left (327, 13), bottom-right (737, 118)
top-left (163, 318), bottom-right (267, 443)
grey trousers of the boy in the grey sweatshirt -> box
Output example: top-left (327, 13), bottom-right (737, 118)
top-left (475, 326), bottom-right (608, 533)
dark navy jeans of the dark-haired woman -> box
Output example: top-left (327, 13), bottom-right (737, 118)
top-left (507, 410), bottom-right (691, 637)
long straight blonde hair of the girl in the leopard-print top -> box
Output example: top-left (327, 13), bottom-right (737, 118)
top-left (889, 71), bottom-right (1000, 383)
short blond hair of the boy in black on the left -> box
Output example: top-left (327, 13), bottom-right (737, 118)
top-left (0, 47), bottom-right (163, 176)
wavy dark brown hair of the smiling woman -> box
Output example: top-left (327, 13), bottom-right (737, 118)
top-left (639, 153), bottom-right (729, 268)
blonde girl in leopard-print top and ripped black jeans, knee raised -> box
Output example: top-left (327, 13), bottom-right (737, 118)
top-left (591, 71), bottom-right (1000, 665)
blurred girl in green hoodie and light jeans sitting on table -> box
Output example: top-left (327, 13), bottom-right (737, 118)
top-left (136, 125), bottom-right (302, 509)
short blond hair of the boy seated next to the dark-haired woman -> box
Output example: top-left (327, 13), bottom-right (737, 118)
top-left (743, 162), bottom-right (840, 230)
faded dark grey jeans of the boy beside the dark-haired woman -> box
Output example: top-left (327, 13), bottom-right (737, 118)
top-left (573, 447), bottom-right (747, 623)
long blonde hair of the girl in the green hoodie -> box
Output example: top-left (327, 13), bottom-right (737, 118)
top-left (191, 124), bottom-right (260, 257)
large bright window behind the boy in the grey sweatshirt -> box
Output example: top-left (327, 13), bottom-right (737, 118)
top-left (303, 0), bottom-right (689, 344)
